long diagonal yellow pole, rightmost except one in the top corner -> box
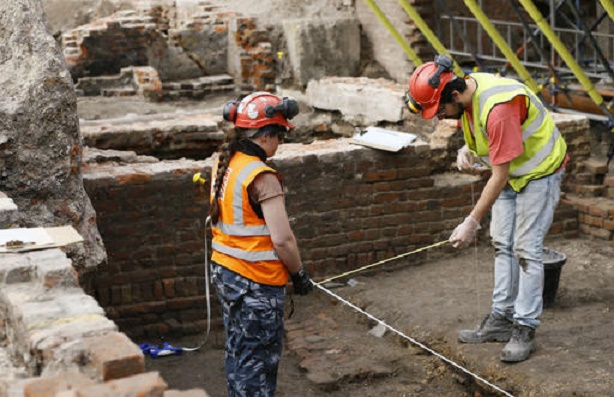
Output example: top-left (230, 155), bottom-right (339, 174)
top-left (518, 0), bottom-right (611, 106)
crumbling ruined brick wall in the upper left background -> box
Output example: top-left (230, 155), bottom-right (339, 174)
top-left (62, 6), bottom-right (232, 81)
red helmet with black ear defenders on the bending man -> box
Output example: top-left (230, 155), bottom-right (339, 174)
top-left (404, 55), bottom-right (455, 119)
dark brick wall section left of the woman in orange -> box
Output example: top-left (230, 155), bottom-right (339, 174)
top-left (84, 161), bottom-right (214, 337)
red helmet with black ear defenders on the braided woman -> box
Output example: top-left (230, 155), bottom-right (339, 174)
top-left (223, 92), bottom-right (299, 129)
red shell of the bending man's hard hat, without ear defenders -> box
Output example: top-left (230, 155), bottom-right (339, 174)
top-left (408, 62), bottom-right (454, 119)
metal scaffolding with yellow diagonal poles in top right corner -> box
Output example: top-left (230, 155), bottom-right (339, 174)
top-left (365, 0), bottom-right (614, 124)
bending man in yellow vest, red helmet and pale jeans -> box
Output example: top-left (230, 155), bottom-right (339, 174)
top-left (405, 55), bottom-right (568, 362)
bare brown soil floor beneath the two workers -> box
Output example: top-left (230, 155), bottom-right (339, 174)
top-left (141, 234), bottom-right (614, 397)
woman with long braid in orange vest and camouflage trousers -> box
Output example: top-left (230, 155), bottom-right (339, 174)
top-left (210, 92), bottom-right (313, 397)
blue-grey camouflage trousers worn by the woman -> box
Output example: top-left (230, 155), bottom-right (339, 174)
top-left (211, 263), bottom-right (285, 397)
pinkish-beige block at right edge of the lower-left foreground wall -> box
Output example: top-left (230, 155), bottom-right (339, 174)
top-left (83, 332), bottom-right (145, 381)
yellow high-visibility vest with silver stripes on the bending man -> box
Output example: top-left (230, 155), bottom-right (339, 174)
top-left (462, 73), bottom-right (566, 191)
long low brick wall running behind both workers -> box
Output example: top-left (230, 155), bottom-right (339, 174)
top-left (84, 118), bottom-right (588, 336)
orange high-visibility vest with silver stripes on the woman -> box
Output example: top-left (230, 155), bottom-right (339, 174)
top-left (211, 152), bottom-right (288, 286)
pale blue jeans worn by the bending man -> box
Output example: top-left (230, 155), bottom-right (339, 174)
top-left (490, 170), bottom-right (563, 328)
